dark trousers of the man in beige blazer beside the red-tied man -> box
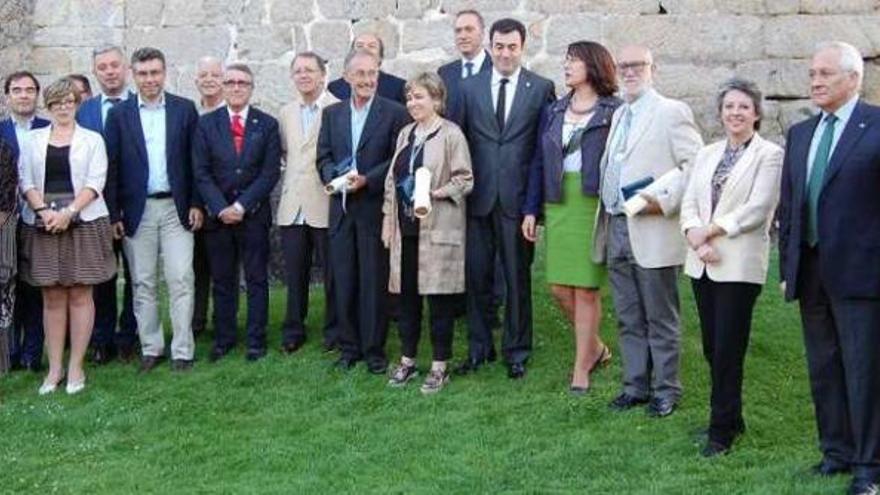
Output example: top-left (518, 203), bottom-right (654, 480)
top-left (280, 225), bottom-right (339, 346)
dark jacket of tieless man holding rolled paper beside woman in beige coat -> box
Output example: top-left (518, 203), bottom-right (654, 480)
top-left (317, 95), bottom-right (410, 235)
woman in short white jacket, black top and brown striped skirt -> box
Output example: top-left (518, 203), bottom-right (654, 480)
top-left (19, 79), bottom-right (116, 395)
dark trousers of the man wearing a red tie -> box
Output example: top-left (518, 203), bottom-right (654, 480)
top-left (206, 213), bottom-right (271, 349)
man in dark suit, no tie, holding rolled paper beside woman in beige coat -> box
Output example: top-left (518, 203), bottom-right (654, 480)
top-left (317, 50), bottom-right (409, 374)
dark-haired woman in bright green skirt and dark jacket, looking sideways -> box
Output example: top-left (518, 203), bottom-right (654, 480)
top-left (522, 41), bottom-right (621, 395)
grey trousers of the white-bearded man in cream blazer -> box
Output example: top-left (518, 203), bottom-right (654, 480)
top-left (607, 215), bottom-right (681, 401)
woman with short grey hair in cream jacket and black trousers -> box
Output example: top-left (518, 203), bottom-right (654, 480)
top-left (681, 79), bottom-right (783, 457)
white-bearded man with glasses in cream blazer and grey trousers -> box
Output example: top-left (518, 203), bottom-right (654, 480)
top-left (593, 46), bottom-right (703, 417)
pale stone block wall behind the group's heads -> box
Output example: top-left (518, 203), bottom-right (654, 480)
top-left (0, 0), bottom-right (880, 138)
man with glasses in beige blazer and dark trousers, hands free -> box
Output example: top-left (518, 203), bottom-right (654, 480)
top-left (275, 52), bottom-right (339, 354)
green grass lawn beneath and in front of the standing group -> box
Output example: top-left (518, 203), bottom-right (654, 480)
top-left (0, 248), bottom-right (848, 494)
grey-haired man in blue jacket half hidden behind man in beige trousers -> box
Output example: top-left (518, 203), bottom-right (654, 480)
top-left (76, 46), bottom-right (137, 364)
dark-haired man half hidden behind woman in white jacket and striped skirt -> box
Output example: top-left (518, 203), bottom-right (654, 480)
top-left (0, 71), bottom-right (49, 371)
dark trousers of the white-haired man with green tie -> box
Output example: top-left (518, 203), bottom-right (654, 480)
top-left (798, 247), bottom-right (880, 481)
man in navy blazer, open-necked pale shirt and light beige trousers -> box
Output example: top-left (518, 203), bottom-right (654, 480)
top-left (104, 48), bottom-right (202, 373)
